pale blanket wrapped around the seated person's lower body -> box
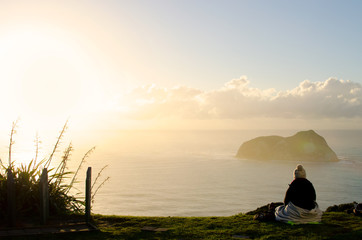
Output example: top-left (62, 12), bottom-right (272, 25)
top-left (275, 202), bottom-right (323, 224)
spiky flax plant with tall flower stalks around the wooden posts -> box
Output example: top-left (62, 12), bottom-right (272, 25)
top-left (0, 121), bottom-right (105, 221)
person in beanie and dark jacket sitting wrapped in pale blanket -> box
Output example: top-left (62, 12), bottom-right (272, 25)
top-left (275, 165), bottom-right (322, 224)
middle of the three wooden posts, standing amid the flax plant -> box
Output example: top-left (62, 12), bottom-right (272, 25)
top-left (39, 168), bottom-right (49, 224)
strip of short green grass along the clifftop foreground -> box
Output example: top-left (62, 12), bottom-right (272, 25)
top-left (9, 212), bottom-right (362, 240)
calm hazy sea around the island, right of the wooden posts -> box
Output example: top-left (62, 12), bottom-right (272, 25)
top-left (82, 131), bottom-right (362, 216)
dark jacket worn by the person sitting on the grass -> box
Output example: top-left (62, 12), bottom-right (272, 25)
top-left (284, 178), bottom-right (316, 210)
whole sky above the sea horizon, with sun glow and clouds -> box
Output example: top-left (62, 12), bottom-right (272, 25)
top-left (0, 0), bottom-right (362, 132)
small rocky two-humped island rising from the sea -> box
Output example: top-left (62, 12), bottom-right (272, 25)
top-left (236, 130), bottom-right (338, 162)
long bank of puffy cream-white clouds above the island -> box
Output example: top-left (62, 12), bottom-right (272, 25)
top-left (115, 76), bottom-right (362, 119)
